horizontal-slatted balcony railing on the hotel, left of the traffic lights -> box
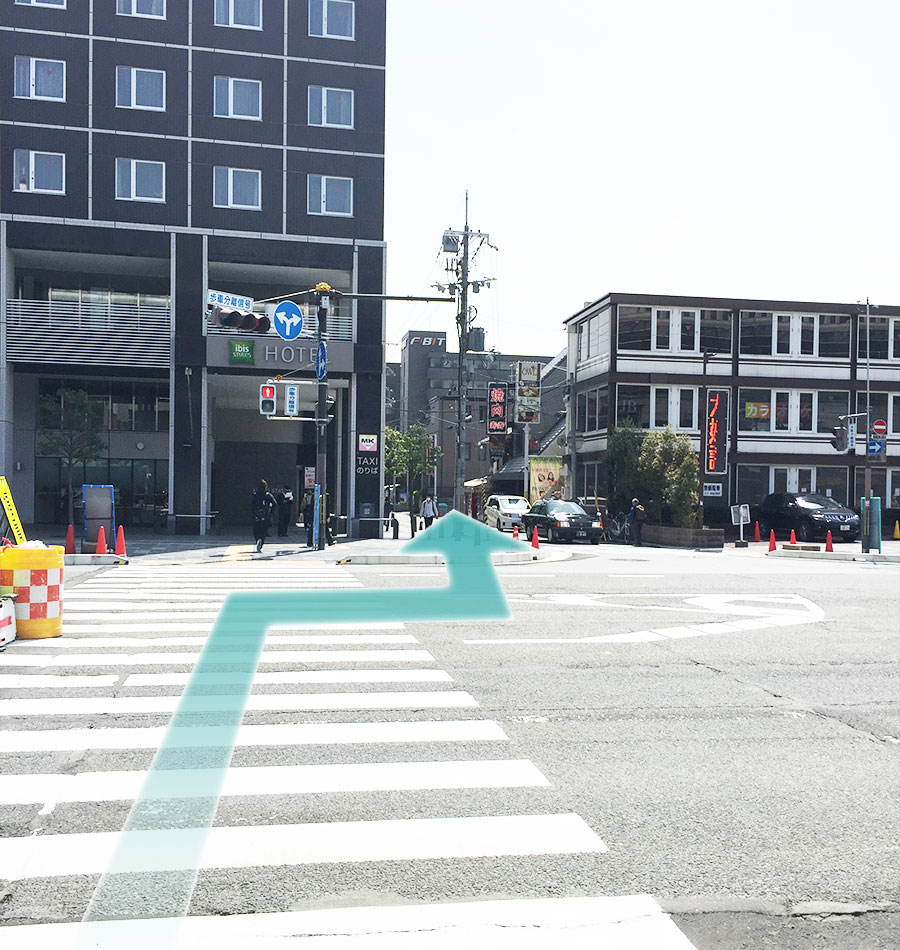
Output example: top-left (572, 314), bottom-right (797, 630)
top-left (6, 300), bottom-right (171, 367)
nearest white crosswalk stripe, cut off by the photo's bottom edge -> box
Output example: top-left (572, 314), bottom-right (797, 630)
top-left (3, 894), bottom-right (694, 950)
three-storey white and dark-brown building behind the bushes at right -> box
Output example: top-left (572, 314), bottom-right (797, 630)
top-left (565, 293), bottom-right (900, 506)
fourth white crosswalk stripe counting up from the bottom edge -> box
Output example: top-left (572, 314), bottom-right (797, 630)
top-left (0, 719), bottom-right (509, 753)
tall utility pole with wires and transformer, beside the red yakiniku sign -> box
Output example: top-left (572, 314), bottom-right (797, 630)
top-left (434, 191), bottom-right (495, 511)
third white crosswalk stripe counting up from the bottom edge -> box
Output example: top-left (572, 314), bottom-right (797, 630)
top-left (0, 759), bottom-right (550, 805)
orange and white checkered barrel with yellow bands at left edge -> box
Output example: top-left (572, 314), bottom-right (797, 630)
top-left (0, 545), bottom-right (63, 640)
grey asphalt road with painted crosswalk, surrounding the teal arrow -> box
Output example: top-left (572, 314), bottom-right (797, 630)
top-left (0, 545), bottom-right (900, 950)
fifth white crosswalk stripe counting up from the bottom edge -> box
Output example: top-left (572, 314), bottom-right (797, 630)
top-left (0, 690), bottom-right (478, 717)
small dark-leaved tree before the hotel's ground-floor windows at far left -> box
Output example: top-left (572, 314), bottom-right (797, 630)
top-left (37, 386), bottom-right (106, 524)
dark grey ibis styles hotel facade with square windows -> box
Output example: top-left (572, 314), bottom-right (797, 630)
top-left (0, 0), bottom-right (385, 533)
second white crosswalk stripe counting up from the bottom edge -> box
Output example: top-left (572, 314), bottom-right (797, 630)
top-left (0, 812), bottom-right (607, 881)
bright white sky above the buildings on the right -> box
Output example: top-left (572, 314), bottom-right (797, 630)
top-left (385, 0), bottom-right (900, 358)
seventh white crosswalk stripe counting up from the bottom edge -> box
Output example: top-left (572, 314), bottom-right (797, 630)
top-left (3, 649), bottom-right (434, 667)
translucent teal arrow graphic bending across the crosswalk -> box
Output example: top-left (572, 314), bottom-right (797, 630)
top-left (84, 512), bottom-right (523, 924)
